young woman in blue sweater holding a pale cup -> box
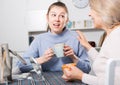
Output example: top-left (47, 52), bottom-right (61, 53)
top-left (18, 2), bottom-right (91, 73)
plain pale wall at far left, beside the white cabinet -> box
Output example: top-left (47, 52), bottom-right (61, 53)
top-left (0, 0), bottom-right (27, 51)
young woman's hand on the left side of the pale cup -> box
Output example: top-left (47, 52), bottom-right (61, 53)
top-left (36, 48), bottom-right (54, 64)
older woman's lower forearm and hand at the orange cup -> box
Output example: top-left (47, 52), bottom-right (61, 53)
top-left (62, 66), bottom-right (104, 85)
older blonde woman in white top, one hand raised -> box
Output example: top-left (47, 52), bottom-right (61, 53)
top-left (62, 0), bottom-right (120, 85)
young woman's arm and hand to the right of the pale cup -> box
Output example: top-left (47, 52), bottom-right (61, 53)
top-left (64, 42), bottom-right (91, 73)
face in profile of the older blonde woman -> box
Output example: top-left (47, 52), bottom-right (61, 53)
top-left (89, 9), bottom-right (102, 28)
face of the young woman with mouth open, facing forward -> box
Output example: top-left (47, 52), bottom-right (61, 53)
top-left (47, 6), bottom-right (68, 34)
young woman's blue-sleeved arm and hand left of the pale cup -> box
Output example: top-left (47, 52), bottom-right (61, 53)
top-left (19, 38), bottom-right (54, 72)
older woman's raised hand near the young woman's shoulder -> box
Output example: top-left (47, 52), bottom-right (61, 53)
top-left (76, 31), bottom-right (92, 50)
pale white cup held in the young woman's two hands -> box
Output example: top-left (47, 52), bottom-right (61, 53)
top-left (53, 43), bottom-right (64, 58)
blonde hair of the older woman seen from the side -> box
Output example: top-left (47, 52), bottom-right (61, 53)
top-left (90, 0), bottom-right (120, 28)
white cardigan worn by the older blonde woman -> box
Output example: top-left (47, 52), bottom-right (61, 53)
top-left (82, 27), bottom-right (120, 85)
